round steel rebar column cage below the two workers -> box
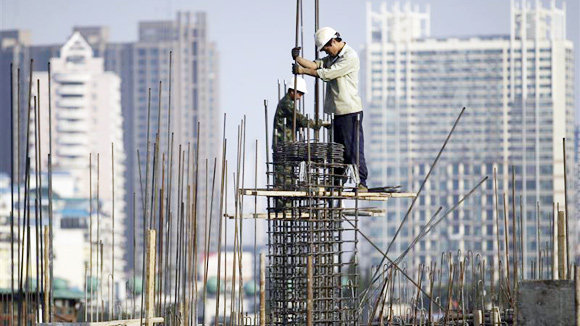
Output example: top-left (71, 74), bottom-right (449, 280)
top-left (268, 142), bottom-right (359, 325)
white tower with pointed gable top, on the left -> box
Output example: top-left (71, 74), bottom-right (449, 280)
top-left (30, 33), bottom-right (127, 287)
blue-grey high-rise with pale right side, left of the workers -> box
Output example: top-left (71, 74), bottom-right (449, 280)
top-left (129, 13), bottom-right (221, 276)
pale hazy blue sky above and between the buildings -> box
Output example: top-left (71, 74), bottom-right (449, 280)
top-left (0, 0), bottom-right (580, 148)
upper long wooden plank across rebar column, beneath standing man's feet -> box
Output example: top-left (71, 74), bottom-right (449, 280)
top-left (239, 188), bottom-right (417, 201)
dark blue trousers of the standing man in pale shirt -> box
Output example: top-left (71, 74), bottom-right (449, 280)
top-left (333, 111), bottom-right (368, 186)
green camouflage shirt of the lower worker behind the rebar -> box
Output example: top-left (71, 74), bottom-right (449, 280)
top-left (272, 93), bottom-right (313, 147)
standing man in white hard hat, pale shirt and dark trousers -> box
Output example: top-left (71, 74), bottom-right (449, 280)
top-left (292, 27), bottom-right (368, 192)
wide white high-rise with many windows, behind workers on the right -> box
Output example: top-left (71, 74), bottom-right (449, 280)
top-left (363, 2), bottom-right (575, 276)
